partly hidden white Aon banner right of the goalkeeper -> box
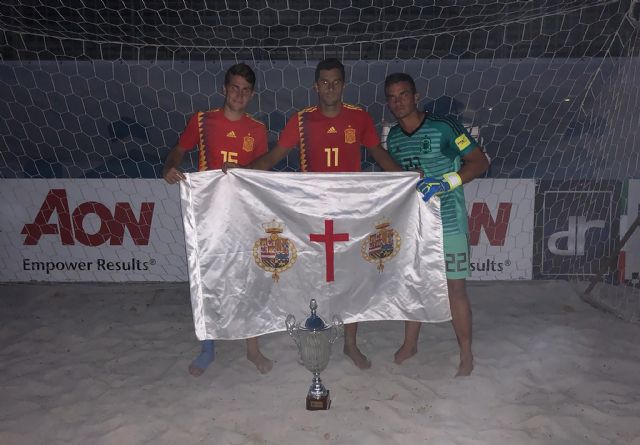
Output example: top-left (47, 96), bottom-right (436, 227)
top-left (464, 179), bottom-right (535, 280)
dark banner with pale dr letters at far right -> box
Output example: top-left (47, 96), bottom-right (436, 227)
top-left (534, 180), bottom-right (620, 278)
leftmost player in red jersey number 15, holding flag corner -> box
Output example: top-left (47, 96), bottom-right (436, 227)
top-left (162, 63), bottom-right (273, 377)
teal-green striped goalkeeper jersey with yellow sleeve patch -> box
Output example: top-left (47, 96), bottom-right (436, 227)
top-left (387, 113), bottom-right (478, 236)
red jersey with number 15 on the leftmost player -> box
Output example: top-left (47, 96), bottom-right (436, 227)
top-left (178, 108), bottom-right (267, 171)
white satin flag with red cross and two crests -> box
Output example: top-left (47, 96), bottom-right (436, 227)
top-left (180, 169), bottom-right (451, 340)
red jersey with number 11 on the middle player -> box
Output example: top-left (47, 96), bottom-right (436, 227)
top-left (278, 104), bottom-right (380, 173)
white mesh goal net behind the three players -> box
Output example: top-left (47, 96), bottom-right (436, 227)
top-left (0, 0), bottom-right (640, 319)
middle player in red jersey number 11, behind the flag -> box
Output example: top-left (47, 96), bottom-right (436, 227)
top-left (238, 59), bottom-right (402, 369)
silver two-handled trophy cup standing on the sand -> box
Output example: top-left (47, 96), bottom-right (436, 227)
top-left (285, 299), bottom-right (343, 411)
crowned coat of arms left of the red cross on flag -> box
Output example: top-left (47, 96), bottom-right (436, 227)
top-left (253, 220), bottom-right (298, 282)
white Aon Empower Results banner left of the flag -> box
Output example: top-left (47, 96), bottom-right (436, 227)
top-left (0, 179), bottom-right (187, 281)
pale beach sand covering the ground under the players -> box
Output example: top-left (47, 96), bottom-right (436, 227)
top-left (0, 281), bottom-right (640, 445)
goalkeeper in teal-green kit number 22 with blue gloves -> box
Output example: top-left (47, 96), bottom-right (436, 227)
top-left (384, 73), bottom-right (489, 376)
